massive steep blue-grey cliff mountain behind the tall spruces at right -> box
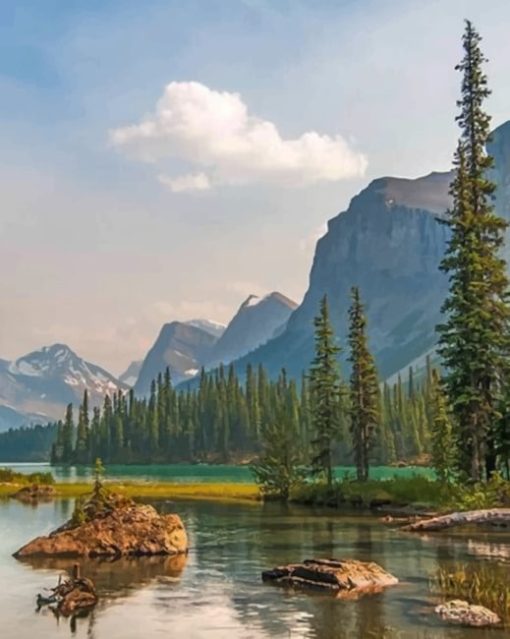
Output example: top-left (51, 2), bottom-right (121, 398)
top-left (230, 122), bottom-right (510, 378)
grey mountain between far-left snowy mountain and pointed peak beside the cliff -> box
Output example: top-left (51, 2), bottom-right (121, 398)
top-left (134, 322), bottom-right (217, 396)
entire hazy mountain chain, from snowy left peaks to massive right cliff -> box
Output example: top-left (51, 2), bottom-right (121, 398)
top-left (0, 122), bottom-right (510, 430)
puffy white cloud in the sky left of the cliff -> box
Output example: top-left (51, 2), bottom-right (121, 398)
top-left (110, 82), bottom-right (367, 191)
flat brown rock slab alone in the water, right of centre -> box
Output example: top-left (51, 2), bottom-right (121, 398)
top-left (262, 559), bottom-right (398, 596)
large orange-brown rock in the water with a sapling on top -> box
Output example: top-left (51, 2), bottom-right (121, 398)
top-left (14, 495), bottom-right (188, 559)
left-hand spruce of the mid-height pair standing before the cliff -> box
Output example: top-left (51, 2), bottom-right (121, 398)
top-left (309, 295), bottom-right (341, 487)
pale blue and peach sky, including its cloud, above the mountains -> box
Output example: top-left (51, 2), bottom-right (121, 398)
top-left (0, 0), bottom-right (510, 374)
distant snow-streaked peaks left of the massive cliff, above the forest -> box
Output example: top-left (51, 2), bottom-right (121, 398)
top-left (0, 293), bottom-right (297, 432)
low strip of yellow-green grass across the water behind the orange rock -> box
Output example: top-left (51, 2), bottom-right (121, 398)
top-left (0, 482), bottom-right (260, 501)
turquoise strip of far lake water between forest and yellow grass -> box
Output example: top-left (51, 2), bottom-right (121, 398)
top-left (0, 462), bottom-right (433, 483)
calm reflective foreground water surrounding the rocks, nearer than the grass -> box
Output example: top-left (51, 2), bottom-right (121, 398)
top-left (0, 500), bottom-right (510, 639)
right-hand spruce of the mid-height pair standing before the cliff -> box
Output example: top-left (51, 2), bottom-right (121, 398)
top-left (349, 287), bottom-right (381, 481)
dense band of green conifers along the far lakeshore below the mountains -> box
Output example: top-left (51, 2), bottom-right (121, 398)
top-left (46, 318), bottom-right (432, 472)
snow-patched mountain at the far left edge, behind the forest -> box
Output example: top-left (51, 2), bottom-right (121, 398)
top-left (0, 344), bottom-right (127, 427)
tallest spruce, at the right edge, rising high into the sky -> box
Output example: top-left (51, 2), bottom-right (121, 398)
top-left (438, 22), bottom-right (510, 481)
